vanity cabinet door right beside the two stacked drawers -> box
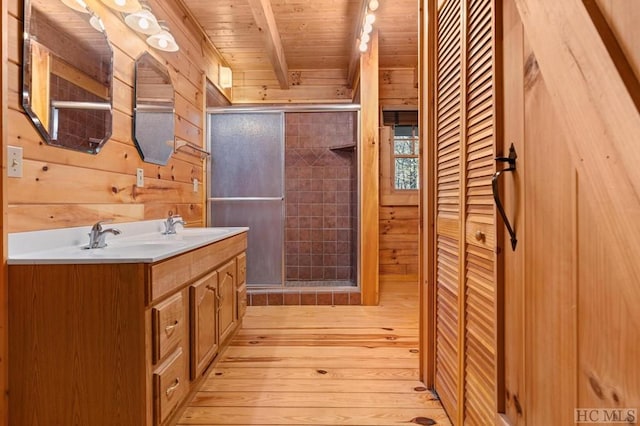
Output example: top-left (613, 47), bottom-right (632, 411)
top-left (189, 271), bottom-right (218, 379)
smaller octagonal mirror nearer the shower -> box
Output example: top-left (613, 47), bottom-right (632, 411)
top-left (133, 52), bottom-right (174, 166)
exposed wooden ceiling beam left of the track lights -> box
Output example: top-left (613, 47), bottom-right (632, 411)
top-left (249, 0), bottom-right (289, 89)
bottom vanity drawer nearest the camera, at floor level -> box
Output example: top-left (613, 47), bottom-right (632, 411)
top-left (153, 348), bottom-right (189, 424)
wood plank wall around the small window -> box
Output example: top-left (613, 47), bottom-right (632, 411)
top-left (380, 68), bottom-right (420, 281)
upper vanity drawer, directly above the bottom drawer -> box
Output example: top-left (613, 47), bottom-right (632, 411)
top-left (151, 293), bottom-right (185, 364)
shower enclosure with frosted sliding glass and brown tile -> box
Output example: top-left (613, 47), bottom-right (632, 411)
top-left (208, 106), bottom-right (358, 289)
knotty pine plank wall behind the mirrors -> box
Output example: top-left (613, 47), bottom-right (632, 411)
top-left (3, 0), bottom-right (230, 232)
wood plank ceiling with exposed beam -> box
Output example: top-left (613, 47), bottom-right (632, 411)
top-left (181, 0), bottom-right (418, 89)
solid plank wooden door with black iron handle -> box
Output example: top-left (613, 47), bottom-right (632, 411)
top-left (500, 0), bottom-right (640, 425)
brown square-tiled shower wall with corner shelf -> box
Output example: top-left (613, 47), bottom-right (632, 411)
top-left (285, 112), bottom-right (357, 285)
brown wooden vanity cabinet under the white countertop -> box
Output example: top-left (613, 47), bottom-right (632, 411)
top-left (9, 233), bottom-right (247, 426)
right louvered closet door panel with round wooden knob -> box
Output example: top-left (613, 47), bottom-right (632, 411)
top-left (464, 0), bottom-right (497, 425)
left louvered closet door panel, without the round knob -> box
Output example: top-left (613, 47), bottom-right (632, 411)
top-left (435, 0), bottom-right (462, 421)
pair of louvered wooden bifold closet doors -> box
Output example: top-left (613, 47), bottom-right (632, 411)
top-left (435, 0), bottom-right (497, 425)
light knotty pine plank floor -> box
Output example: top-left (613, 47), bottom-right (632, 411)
top-left (178, 283), bottom-right (450, 426)
